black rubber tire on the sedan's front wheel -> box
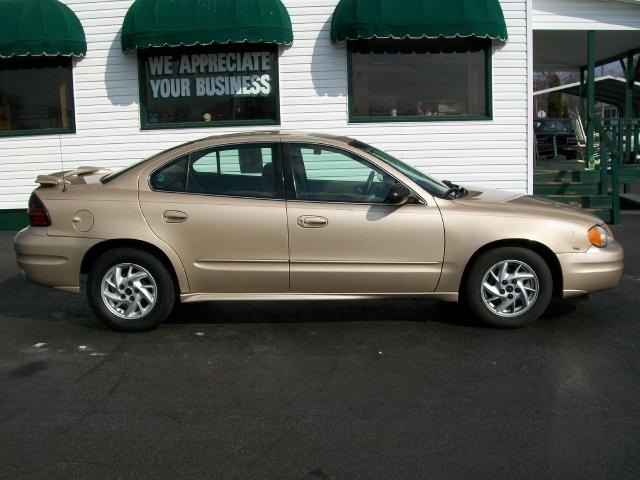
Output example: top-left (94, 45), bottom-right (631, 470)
top-left (463, 247), bottom-right (553, 328)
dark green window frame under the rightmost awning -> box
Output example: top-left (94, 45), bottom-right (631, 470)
top-left (347, 39), bottom-right (493, 124)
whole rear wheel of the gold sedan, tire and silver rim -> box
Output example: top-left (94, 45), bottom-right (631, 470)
top-left (87, 248), bottom-right (175, 332)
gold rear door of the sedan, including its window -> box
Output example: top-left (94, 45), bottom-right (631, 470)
top-left (140, 143), bottom-right (289, 293)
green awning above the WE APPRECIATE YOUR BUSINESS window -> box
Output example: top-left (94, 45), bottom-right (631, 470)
top-left (122, 0), bottom-right (293, 52)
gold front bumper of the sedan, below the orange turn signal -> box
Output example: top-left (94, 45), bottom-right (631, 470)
top-left (558, 242), bottom-right (624, 298)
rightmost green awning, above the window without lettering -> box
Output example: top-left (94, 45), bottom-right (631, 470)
top-left (331, 0), bottom-right (508, 42)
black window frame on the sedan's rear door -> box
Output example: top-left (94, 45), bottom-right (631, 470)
top-left (147, 141), bottom-right (286, 201)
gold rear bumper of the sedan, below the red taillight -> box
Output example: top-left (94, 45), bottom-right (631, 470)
top-left (13, 227), bottom-right (99, 292)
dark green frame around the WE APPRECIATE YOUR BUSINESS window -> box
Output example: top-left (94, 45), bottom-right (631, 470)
top-left (136, 43), bottom-right (282, 130)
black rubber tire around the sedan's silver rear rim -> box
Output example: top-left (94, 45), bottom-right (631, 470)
top-left (87, 248), bottom-right (176, 332)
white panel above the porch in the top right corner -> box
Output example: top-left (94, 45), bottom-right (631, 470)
top-left (532, 0), bottom-right (640, 30)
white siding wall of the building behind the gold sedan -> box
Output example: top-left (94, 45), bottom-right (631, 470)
top-left (0, 0), bottom-right (531, 209)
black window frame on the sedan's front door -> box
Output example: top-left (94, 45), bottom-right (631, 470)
top-left (280, 141), bottom-right (427, 204)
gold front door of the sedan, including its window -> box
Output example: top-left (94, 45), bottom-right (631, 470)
top-left (283, 142), bottom-right (444, 294)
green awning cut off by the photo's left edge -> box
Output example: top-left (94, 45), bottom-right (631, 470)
top-left (0, 0), bottom-right (87, 57)
